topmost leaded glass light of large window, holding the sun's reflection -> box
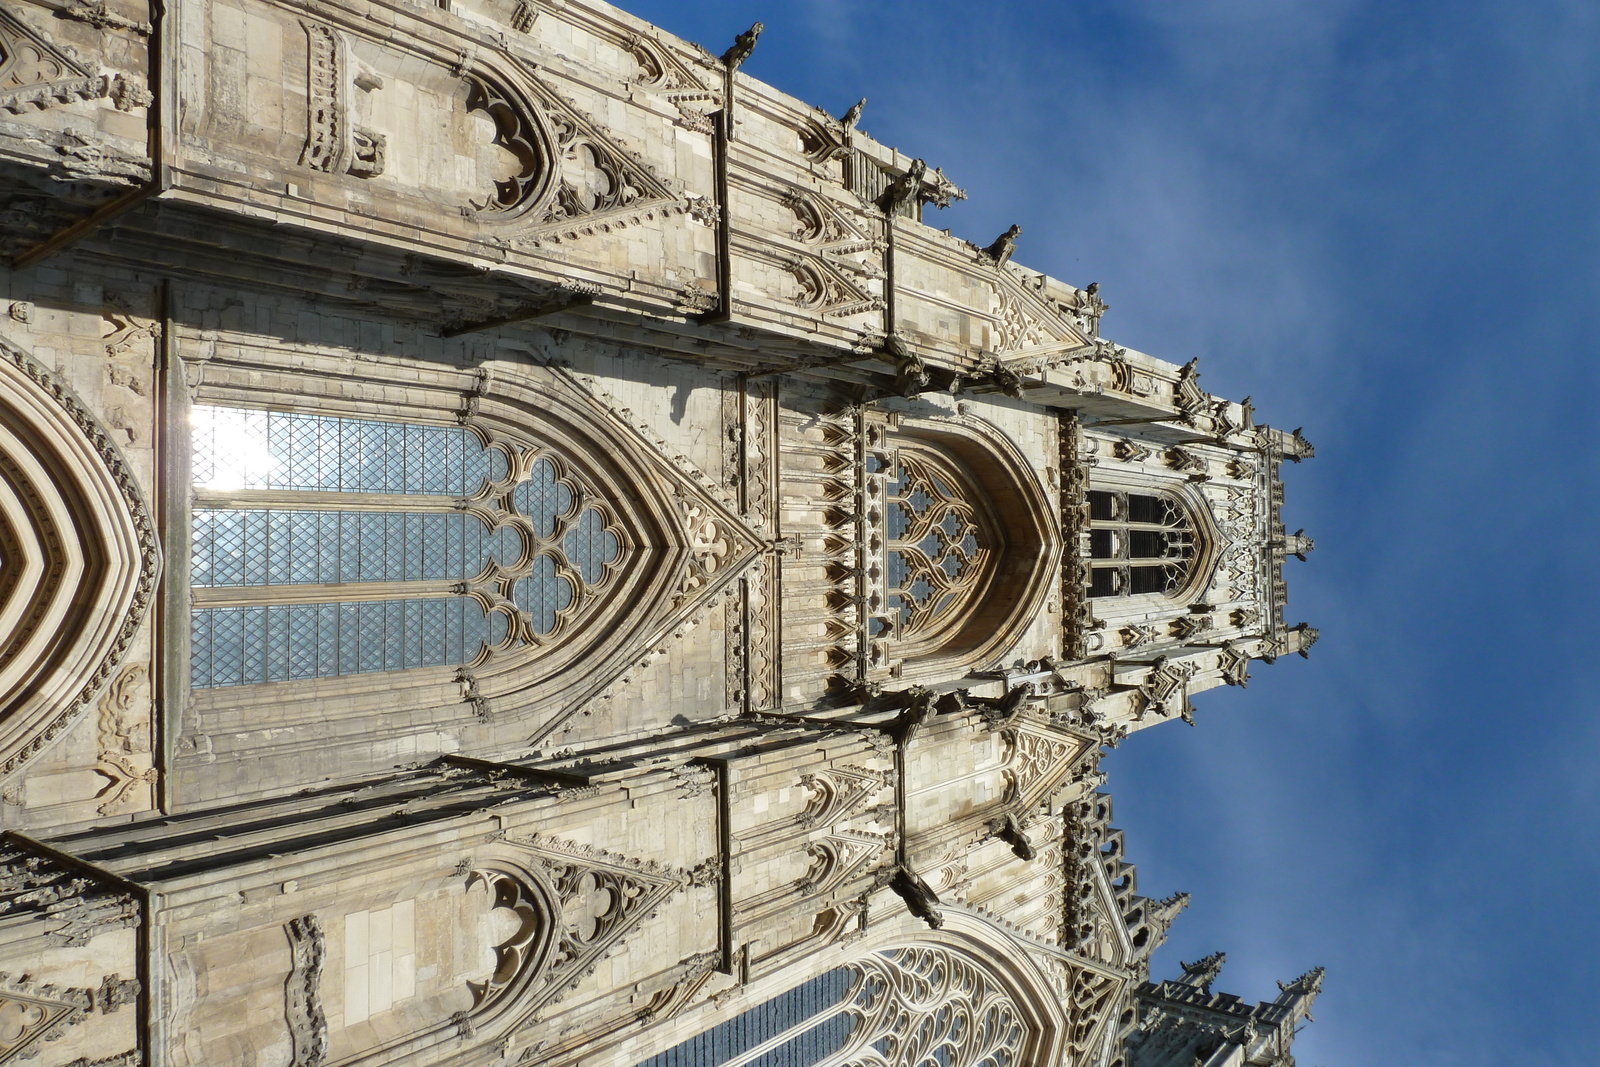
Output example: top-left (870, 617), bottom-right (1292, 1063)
top-left (192, 405), bottom-right (507, 496)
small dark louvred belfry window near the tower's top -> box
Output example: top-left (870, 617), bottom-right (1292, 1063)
top-left (1088, 490), bottom-right (1195, 597)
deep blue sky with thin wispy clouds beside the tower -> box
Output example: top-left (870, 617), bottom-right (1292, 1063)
top-left (624, 0), bottom-right (1600, 1067)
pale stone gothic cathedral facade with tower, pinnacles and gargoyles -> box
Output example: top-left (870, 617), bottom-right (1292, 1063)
top-left (0, 0), bottom-right (1322, 1067)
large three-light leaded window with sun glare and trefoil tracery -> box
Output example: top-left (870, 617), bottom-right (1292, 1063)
top-left (190, 406), bottom-right (627, 689)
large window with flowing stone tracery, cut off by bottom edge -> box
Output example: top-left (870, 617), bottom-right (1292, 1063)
top-left (640, 945), bottom-right (1037, 1067)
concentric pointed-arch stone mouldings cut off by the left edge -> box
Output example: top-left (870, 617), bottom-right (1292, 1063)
top-left (0, 339), bottom-right (162, 776)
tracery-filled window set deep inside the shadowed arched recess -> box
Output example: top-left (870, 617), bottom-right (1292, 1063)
top-left (885, 448), bottom-right (989, 640)
